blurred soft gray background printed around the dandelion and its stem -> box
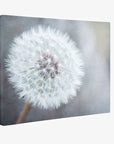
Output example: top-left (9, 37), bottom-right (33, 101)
top-left (0, 16), bottom-right (110, 125)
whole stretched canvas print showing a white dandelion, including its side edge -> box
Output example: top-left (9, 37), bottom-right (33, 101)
top-left (0, 15), bottom-right (110, 125)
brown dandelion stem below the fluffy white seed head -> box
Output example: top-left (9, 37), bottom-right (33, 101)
top-left (16, 102), bottom-right (32, 124)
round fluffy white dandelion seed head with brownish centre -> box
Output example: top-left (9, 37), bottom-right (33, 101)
top-left (6, 26), bottom-right (84, 122)
